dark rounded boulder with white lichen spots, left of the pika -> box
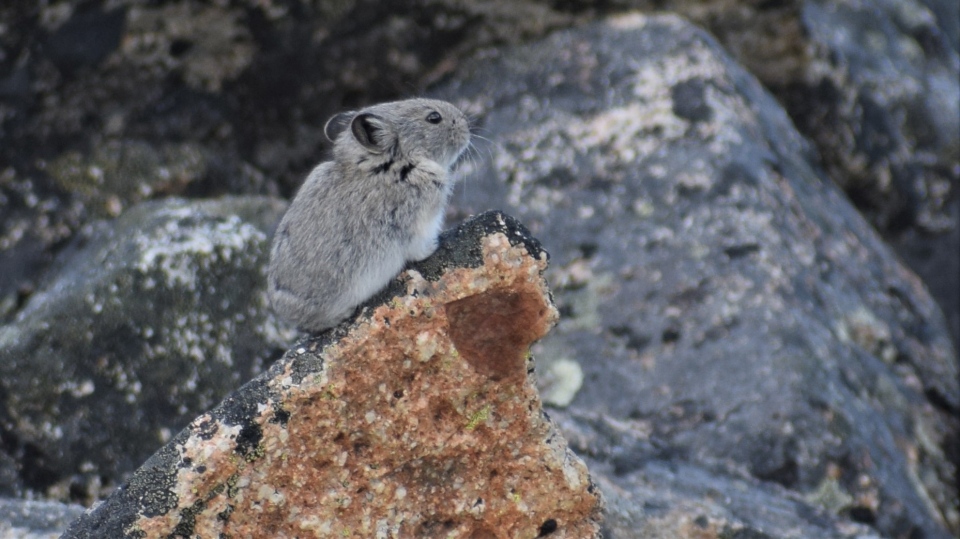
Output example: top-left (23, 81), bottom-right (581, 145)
top-left (0, 197), bottom-right (290, 502)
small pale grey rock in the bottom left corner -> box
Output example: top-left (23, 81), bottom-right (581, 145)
top-left (0, 498), bottom-right (84, 539)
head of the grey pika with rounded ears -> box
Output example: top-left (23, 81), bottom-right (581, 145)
top-left (324, 99), bottom-right (470, 169)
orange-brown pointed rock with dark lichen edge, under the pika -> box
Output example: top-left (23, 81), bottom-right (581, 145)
top-left (64, 212), bottom-right (600, 539)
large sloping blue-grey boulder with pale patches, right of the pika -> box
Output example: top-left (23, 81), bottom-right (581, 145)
top-left (437, 11), bottom-right (960, 538)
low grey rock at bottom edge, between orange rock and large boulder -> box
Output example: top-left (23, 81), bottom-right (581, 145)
top-left (554, 412), bottom-right (886, 539)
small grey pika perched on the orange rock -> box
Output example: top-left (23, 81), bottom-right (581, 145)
top-left (267, 99), bottom-right (470, 333)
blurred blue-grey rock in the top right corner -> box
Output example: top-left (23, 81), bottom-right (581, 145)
top-left (800, 0), bottom-right (960, 346)
